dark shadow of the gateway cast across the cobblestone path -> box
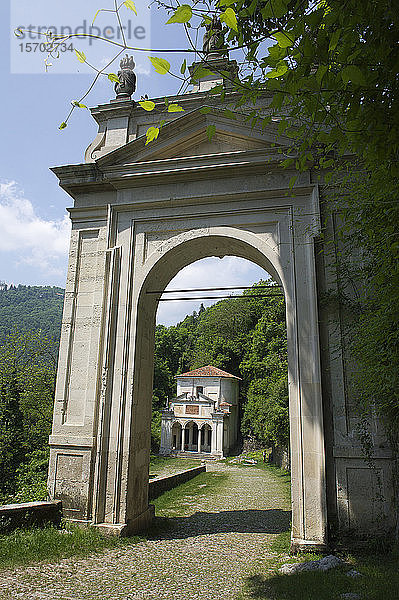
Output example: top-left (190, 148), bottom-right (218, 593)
top-left (147, 508), bottom-right (291, 540)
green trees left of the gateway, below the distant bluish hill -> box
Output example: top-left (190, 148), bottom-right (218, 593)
top-left (0, 331), bottom-right (58, 500)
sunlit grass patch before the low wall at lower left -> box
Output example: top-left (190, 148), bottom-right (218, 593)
top-left (0, 526), bottom-right (140, 569)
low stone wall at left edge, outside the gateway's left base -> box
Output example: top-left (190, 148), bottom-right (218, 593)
top-left (0, 500), bottom-right (62, 533)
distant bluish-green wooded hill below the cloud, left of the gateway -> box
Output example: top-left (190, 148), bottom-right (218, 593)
top-left (0, 284), bottom-right (65, 340)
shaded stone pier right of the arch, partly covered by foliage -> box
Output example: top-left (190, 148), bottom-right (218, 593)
top-left (315, 192), bottom-right (396, 537)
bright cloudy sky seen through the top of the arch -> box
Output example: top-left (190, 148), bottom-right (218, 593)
top-left (157, 256), bottom-right (269, 325)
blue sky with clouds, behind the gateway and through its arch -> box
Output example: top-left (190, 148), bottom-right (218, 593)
top-left (0, 0), bottom-right (265, 324)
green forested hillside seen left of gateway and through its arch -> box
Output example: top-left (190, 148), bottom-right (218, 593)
top-left (0, 281), bottom-right (288, 503)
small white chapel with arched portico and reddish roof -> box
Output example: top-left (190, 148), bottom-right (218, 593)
top-left (160, 365), bottom-right (240, 458)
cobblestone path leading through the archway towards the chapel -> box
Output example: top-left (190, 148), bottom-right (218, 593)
top-left (0, 463), bottom-right (289, 600)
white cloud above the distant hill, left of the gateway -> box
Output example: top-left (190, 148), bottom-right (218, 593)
top-left (0, 181), bottom-right (70, 276)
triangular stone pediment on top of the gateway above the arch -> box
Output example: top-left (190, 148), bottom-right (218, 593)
top-left (97, 109), bottom-right (289, 166)
